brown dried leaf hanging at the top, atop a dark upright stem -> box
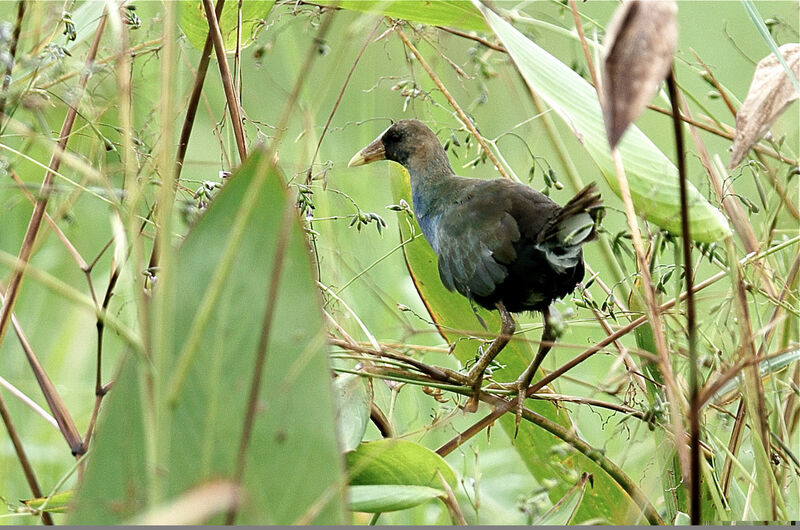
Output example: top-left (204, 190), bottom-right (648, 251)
top-left (603, 0), bottom-right (678, 148)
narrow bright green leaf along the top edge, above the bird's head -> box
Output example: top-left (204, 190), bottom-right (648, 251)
top-left (316, 0), bottom-right (488, 31)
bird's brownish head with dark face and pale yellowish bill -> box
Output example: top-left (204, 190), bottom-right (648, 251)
top-left (347, 120), bottom-right (453, 175)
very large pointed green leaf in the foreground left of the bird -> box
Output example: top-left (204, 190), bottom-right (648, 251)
top-left (70, 150), bottom-right (345, 524)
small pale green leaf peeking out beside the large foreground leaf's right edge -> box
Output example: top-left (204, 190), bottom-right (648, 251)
top-left (333, 374), bottom-right (372, 452)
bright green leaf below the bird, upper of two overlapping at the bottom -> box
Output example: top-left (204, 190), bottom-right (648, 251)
top-left (347, 438), bottom-right (458, 492)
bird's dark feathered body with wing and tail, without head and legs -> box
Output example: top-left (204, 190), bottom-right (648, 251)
top-left (420, 177), bottom-right (601, 312)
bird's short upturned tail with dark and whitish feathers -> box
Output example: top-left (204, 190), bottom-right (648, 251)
top-left (538, 182), bottom-right (603, 271)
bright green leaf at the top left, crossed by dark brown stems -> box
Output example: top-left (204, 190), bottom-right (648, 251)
top-left (179, 0), bottom-right (275, 53)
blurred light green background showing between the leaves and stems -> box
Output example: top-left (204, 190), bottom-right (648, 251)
top-left (0, 1), bottom-right (799, 524)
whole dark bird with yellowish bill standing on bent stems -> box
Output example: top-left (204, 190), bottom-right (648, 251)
top-left (348, 119), bottom-right (603, 412)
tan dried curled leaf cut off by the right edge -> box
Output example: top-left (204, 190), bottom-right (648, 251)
top-left (728, 43), bottom-right (800, 169)
